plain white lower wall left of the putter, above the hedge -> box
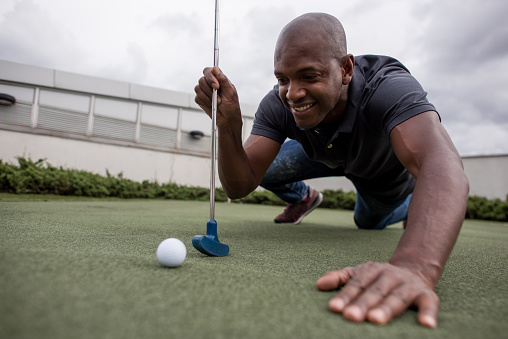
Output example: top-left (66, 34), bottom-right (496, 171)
top-left (0, 130), bottom-right (214, 187)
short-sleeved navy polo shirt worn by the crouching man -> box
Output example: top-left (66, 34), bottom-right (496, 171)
top-left (251, 55), bottom-right (436, 202)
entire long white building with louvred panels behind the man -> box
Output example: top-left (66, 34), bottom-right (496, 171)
top-left (0, 60), bottom-right (508, 200)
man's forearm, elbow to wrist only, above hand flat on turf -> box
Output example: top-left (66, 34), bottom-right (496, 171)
top-left (390, 163), bottom-right (469, 287)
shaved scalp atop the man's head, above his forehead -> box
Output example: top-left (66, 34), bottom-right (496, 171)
top-left (274, 13), bottom-right (347, 61)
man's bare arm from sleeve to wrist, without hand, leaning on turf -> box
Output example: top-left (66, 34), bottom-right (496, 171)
top-left (390, 112), bottom-right (469, 286)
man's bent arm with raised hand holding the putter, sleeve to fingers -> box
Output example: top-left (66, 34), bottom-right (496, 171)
top-left (194, 67), bottom-right (280, 199)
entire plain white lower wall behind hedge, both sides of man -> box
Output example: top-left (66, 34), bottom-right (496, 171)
top-left (0, 130), bottom-right (508, 201)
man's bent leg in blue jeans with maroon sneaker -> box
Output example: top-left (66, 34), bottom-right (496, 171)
top-left (260, 140), bottom-right (340, 224)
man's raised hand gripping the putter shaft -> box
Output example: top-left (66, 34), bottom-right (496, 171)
top-left (194, 66), bottom-right (242, 128)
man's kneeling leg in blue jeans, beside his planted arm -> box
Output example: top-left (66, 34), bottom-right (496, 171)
top-left (354, 188), bottom-right (412, 230)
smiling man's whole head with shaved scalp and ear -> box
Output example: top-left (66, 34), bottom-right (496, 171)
top-left (274, 13), bottom-right (354, 128)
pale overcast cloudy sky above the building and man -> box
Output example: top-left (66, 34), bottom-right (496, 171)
top-left (0, 0), bottom-right (508, 156)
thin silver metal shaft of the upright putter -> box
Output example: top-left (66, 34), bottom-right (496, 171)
top-left (210, 0), bottom-right (220, 220)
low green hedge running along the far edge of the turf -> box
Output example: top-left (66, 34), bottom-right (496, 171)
top-left (0, 157), bottom-right (508, 221)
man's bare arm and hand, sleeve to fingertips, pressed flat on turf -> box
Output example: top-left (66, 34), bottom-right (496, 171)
top-left (317, 112), bottom-right (469, 327)
